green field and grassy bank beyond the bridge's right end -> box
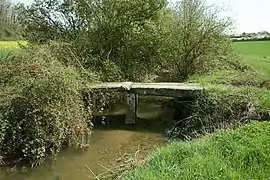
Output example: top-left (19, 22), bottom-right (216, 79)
top-left (188, 41), bottom-right (270, 112)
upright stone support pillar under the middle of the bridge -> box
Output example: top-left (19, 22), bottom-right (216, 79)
top-left (125, 93), bottom-right (138, 124)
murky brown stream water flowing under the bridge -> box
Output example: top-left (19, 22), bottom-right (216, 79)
top-left (0, 96), bottom-right (173, 180)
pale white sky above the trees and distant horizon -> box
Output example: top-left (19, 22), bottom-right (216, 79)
top-left (13, 0), bottom-right (270, 33)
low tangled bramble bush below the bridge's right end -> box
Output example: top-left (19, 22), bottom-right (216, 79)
top-left (168, 86), bottom-right (269, 139)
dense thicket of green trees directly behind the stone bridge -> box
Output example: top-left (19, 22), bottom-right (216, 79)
top-left (20, 0), bottom-right (234, 81)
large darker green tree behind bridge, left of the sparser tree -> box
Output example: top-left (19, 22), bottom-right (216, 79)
top-left (20, 0), bottom-right (166, 80)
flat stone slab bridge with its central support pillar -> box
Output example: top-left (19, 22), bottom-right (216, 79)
top-left (89, 82), bottom-right (203, 124)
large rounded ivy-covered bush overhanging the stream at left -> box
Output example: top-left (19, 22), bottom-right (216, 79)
top-left (0, 46), bottom-right (94, 166)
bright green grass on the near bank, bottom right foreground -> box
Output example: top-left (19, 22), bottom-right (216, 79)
top-left (125, 122), bottom-right (270, 180)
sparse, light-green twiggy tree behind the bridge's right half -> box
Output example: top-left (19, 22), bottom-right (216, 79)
top-left (159, 0), bottom-right (233, 81)
